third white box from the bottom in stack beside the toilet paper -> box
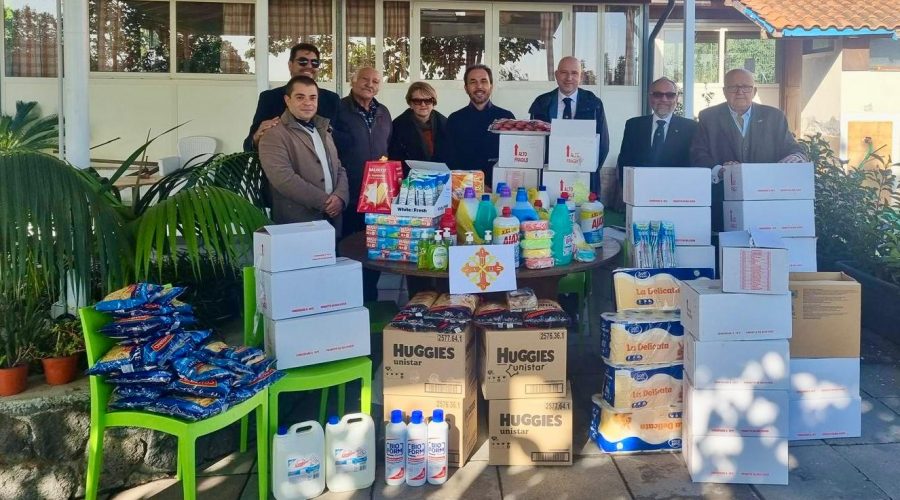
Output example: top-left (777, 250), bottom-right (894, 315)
top-left (684, 335), bottom-right (791, 390)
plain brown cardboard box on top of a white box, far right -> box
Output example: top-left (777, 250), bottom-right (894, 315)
top-left (789, 273), bottom-right (862, 358)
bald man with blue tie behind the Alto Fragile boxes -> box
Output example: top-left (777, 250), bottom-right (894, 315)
top-left (528, 56), bottom-right (609, 193)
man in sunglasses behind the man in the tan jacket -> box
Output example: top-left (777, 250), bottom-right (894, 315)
top-left (244, 43), bottom-right (341, 151)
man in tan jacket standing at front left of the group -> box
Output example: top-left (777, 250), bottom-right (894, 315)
top-left (259, 75), bottom-right (350, 234)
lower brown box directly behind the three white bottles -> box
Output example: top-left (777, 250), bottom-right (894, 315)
top-left (382, 388), bottom-right (478, 467)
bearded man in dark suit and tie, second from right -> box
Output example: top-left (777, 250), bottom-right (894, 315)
top-left (616, 77), bottom-right (697, 186)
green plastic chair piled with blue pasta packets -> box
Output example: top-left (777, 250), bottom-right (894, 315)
top-left (79, 307), bottom-right (270, 500)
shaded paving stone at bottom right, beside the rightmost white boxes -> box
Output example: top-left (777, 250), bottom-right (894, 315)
top-left (754, 445), bottom-right (887, 500)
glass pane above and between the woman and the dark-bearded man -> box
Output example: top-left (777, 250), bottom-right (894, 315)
top-left (420, 9), bottom-right (485, 80)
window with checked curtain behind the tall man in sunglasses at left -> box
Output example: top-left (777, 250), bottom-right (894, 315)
top-left (269, 0), bottom-right (334, 82)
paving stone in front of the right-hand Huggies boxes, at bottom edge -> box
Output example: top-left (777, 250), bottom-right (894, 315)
top-left (498, 456), bottom-right (631, 500)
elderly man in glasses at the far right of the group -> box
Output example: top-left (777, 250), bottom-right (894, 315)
top-left (691, 69), bottom-right (808, 231)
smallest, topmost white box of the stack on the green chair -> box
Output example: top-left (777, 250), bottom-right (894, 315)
top-left (253, 220), bottom-right (337, 273)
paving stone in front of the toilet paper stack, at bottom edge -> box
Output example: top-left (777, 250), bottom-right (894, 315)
top-left (613, 453), bottom-right (757, 500)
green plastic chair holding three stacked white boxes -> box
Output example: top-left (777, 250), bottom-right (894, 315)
top-left (241, 267), bottom-right (372, 451)
